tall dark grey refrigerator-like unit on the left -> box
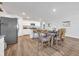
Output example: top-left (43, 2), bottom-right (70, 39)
top-left (1, 17), bottom-right (17, 44)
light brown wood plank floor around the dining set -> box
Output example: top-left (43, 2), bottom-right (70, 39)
top-left (5, 36), bottom-right (79, 56)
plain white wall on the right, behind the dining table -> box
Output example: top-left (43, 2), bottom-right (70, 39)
top-left (52, 15), bottom-right (79, 38)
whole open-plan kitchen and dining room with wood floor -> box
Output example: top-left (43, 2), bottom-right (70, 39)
top-left (0, 2), bottom-right (79, 56)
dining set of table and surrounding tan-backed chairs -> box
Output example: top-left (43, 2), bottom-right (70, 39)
top-left (33, 28), bottom-right (66, 49)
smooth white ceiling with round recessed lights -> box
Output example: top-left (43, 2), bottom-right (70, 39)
top-left (3, 2), bottom-right (79, 22)
